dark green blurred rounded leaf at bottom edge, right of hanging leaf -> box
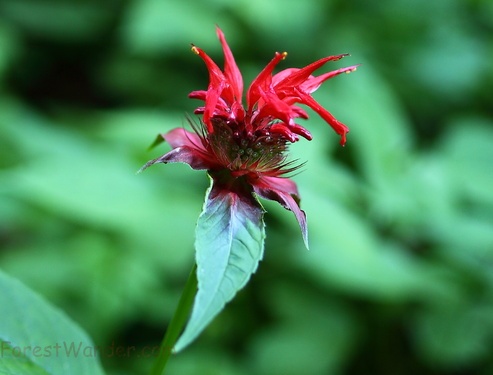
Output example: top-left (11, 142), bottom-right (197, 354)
top-left (249, 282), bottom-right (359, 375)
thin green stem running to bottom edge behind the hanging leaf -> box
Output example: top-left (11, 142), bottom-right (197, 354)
top-left (150, 263), bottom-right (197, 375)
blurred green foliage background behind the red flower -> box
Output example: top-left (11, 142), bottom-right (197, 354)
top-left (0, 0), bottom-right (493, 375)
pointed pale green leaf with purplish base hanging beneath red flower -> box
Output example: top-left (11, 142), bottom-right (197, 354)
top-left (174, 178), bottom-right (265, 351)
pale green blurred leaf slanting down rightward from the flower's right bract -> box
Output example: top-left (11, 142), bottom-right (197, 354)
top-left (293, 188), bottom-right (455, 301)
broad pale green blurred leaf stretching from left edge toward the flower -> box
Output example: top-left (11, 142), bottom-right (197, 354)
top-left (0, 103), bottom-right (200, 270)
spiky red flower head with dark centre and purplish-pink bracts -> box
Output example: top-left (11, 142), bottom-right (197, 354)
top-left (143, 28), bottom-right (357, 247)
